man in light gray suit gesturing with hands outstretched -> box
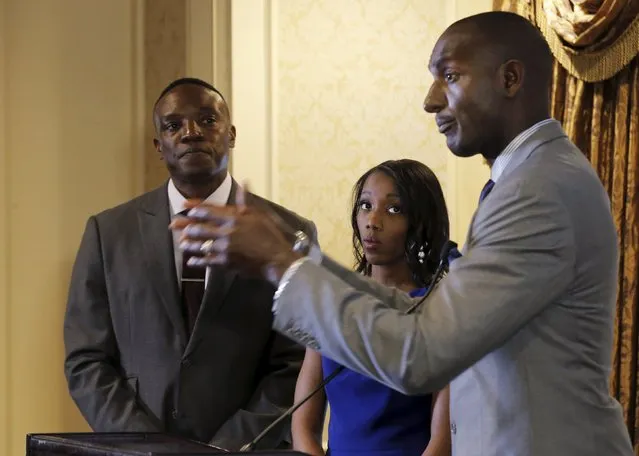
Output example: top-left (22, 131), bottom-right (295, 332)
top-left (174, 12), bottom-right (633, 456)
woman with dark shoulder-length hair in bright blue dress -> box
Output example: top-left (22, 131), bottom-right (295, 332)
top-left (292, 160), bottom-right (451, 456)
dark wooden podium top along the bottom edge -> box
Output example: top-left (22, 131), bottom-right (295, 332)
top-left (26, 432), bottom-right (312, 456)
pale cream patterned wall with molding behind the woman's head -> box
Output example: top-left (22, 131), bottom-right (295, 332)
top-left (231, 0), bottom-right (492, 264)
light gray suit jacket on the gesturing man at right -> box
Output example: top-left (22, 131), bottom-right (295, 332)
top-left (275, 123), bottom-right (633, 456)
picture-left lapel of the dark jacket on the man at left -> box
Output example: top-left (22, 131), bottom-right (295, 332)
top-left (138, 185), bottom-right (186, 346)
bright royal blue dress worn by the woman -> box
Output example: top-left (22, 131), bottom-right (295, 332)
top-left (322, 288), bottom-right (432, 456)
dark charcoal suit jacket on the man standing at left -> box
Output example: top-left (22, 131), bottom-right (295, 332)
top-left (64, 183), bottom-right (315, 449)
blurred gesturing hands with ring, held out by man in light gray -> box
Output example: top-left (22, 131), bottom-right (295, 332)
top-left (170, 183), bottom-right (299, 282)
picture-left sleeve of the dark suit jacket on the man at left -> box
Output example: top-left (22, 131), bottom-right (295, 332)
top-left (64, 217), bottom-right (162, 432)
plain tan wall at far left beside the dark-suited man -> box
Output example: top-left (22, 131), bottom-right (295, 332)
top-left (0, 0), bottom-right (142, 455)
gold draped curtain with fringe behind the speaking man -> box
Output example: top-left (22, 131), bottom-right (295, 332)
top-left (493, 0), bottom-right (639, 456)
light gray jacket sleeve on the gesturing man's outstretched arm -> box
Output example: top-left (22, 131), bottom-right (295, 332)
top-left (274, 178), bottom-right (575, 394)
